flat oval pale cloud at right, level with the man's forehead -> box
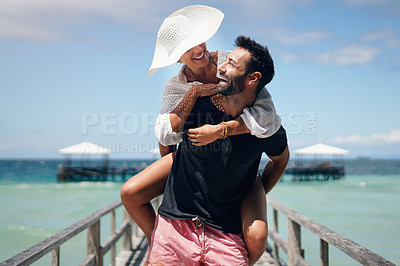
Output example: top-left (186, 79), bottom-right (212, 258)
top-left (314, 45), bottom-right (380, 66)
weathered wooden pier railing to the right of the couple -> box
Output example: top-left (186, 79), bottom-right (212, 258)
top-left (267, 197), bottom-right (395, 266)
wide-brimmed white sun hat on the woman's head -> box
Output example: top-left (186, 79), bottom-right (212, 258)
top-left (147, 5), bottom-right (224, 76)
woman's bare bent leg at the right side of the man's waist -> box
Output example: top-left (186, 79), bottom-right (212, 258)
top-left (241, 177), bottom-right (268, 265)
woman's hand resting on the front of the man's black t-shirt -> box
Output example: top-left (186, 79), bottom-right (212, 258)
top-left (188, 124), bottom-right (224, 146)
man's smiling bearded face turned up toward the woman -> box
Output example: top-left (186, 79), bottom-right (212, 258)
top-left (217, 48), bottom-right (250, 96)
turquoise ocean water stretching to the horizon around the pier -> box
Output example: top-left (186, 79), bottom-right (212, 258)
top-left (0, 158), bottom-right (400, 265)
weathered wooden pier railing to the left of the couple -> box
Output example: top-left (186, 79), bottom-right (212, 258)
top-left (0, 200), bottom-right (132, 266)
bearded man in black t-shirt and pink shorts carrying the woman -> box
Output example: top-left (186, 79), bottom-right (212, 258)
top-left (149, 36), bottom-right (289, 265)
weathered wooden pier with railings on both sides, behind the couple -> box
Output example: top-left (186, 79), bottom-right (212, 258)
top-left (0, 197), bottom-right (395, 266)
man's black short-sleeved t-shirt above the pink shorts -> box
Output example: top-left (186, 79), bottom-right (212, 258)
top-left (159, 97), bottom-right (287, 233)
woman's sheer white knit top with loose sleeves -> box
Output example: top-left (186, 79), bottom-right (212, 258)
top-left (155, 51), bottom-right (281, 146)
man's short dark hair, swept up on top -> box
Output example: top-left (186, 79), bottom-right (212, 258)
top-left (235, 35), bottom-right (275, 91)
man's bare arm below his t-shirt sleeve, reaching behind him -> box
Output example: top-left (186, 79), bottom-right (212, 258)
top-left (262, 147), bottom-right (290, 194)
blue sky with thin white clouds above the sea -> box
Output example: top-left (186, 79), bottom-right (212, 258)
top-left (0, 0), bottom-right (400, 158)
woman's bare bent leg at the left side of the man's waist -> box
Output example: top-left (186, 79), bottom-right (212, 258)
top-left (121, 153), bottom-right (175, 243)
